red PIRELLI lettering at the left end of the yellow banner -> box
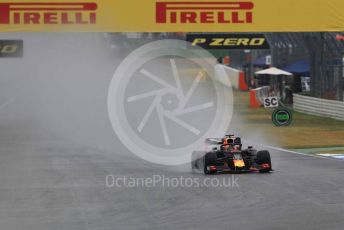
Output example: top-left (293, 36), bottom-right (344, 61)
top-left (0, 2), bottom-right (98, 25)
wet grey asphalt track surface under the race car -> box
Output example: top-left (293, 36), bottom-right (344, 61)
top-left (0, 142), bottom-right (344, 230)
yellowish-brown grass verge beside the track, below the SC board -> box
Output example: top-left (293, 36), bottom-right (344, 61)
top-left (234, 91), bottom-right (344, 149)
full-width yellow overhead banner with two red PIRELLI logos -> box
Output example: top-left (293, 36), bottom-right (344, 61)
top-left (0, 0), bottom-right (344, 32)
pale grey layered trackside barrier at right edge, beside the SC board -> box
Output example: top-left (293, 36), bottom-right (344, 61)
top-left (293, 94), bottom-right (344, 121)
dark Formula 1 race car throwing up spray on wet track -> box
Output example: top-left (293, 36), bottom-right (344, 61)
top-left (191, 135), bottom-right (272, 174)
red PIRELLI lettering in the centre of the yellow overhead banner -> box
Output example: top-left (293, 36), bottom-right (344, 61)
top-left (156, 1), bottom-right (254, 24)
